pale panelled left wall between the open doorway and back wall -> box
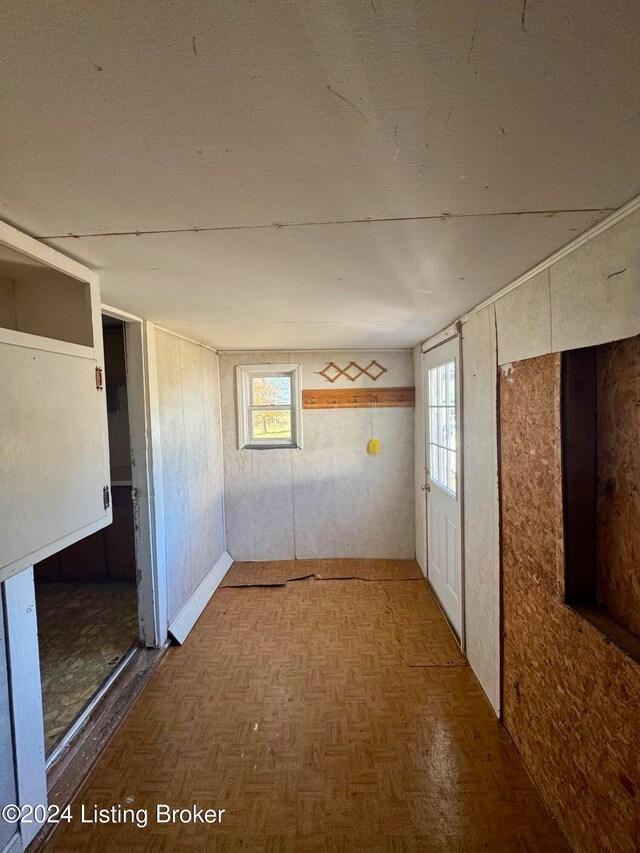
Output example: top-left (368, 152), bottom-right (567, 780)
top-left (155, 329), bottom-right (226, 622)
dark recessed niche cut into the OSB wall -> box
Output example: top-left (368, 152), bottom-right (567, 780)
top-left (562, 336), bottom-right (640, 659)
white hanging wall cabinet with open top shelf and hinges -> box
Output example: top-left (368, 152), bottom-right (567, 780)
top-left (0, 223), bottom-right (111, 580)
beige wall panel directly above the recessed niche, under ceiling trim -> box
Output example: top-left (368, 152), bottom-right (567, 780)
top-left (549, 211), bottom-right (640, 352)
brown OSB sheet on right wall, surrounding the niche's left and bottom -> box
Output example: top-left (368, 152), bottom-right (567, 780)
top-left (500, 354), bottom-right (640, 853)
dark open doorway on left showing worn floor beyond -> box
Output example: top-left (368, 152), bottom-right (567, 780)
top-left (34, 316), bottom-right (139, 756)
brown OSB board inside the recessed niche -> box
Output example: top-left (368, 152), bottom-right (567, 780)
top-left (597, 335), bottom-right (640, 634)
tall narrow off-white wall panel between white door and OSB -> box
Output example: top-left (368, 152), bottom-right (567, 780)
top-left (462, 306), bottom-right (500, 712)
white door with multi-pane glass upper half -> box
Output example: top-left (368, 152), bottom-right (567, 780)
top-left (424, 337), bottom-right (462, 637)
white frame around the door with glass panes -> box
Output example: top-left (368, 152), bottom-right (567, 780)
top-left (420, 332), bottom-right (467, 655)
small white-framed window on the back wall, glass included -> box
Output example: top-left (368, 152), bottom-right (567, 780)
top-left (236, 364), bottom-right (302, 450)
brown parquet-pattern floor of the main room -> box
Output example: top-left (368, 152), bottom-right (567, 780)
top-left (46, 560), bottom-right (568, 853)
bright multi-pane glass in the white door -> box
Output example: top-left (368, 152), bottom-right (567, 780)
top-left (429, 361), bottom-right (457, 497)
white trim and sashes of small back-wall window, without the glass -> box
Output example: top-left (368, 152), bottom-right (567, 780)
top-left (236, 364), bottom-right (302, 450)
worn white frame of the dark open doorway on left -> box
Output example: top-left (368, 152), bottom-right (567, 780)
top-left (101, 304), bottom-right (167, 649)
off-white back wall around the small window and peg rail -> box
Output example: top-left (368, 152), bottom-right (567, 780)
top-left (220, 350), bottom-right (415, 560)
